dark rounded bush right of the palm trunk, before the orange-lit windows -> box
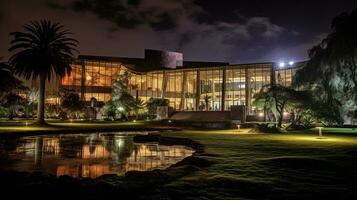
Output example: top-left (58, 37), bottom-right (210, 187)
top-left (61, 92), bottom-right (84, 118)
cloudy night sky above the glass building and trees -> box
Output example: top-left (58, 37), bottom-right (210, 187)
top-left (0, 0), bottom-right (357, 63)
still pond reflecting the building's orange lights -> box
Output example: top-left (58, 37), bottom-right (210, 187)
top-left (0, 133), bottom-right (194, 178)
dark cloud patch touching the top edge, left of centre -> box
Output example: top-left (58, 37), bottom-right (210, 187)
top-left (65, 0), bottom-right (186, 31)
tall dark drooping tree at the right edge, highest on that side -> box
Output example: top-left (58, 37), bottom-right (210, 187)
top-left (293, 10), bottom-right (357, 124)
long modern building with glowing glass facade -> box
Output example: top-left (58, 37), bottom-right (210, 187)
top-left (55, 50), bottom-right (301, 114)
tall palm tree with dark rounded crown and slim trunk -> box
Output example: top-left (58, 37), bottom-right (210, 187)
top-left (9, 20), bottom-right (78, 125)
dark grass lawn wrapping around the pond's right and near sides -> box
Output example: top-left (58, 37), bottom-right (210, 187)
top-left (0, 126), bottom-right (357, 200)
